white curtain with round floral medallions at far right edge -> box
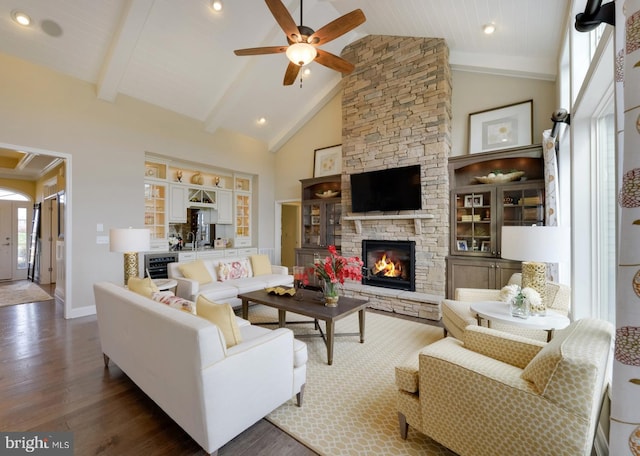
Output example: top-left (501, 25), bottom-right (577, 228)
top-left (609, 0), bottom-right (640, 456)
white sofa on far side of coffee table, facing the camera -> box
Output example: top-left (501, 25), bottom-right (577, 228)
top-left (167, 257), bottom-right (293, 307)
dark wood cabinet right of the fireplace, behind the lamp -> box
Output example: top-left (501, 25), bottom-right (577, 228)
top-left (447, 145), bottom-right (545, 298)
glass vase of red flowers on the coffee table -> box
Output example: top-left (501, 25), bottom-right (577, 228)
top-left (303, 245), bottom-right (364, 307)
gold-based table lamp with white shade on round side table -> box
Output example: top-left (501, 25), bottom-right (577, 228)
top-left (500, 225), bottom-right (569, 308)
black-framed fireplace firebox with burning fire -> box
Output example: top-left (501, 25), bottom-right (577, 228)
top-left (362, 239), bottom-right (416, 291)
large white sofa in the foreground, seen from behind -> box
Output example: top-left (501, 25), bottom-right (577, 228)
top-left (94, 282), bottom-right (307, 454)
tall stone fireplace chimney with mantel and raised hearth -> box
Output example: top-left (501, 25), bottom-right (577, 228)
top-left (342, 35), bottom-right (451, 320)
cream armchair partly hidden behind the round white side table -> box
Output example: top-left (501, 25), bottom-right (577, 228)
top-left (442, 273), bottom-right (571, 341)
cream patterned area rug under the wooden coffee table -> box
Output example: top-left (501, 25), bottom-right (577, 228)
top-left (244, 306), bottom-right (454, 456)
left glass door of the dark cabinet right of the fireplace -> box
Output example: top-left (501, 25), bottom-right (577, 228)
top-left (452, 188), bottom-right (497, 256)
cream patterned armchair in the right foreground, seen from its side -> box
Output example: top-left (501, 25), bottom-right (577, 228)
top-left (396, 319), bottom-right (613, 456)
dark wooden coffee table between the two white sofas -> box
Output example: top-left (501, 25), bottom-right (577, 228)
top-left (238, 290), bottom-right (368, 365)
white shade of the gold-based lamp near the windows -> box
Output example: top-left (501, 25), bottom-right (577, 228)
top-left (500, 226), bottom-right (570, 263)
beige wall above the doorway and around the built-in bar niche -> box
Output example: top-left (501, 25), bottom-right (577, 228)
top-left (0, 55), bottom-right (275, 316)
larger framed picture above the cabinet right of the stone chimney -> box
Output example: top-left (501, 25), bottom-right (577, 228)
top-left (469, 100), bottom-right (533, 154)
